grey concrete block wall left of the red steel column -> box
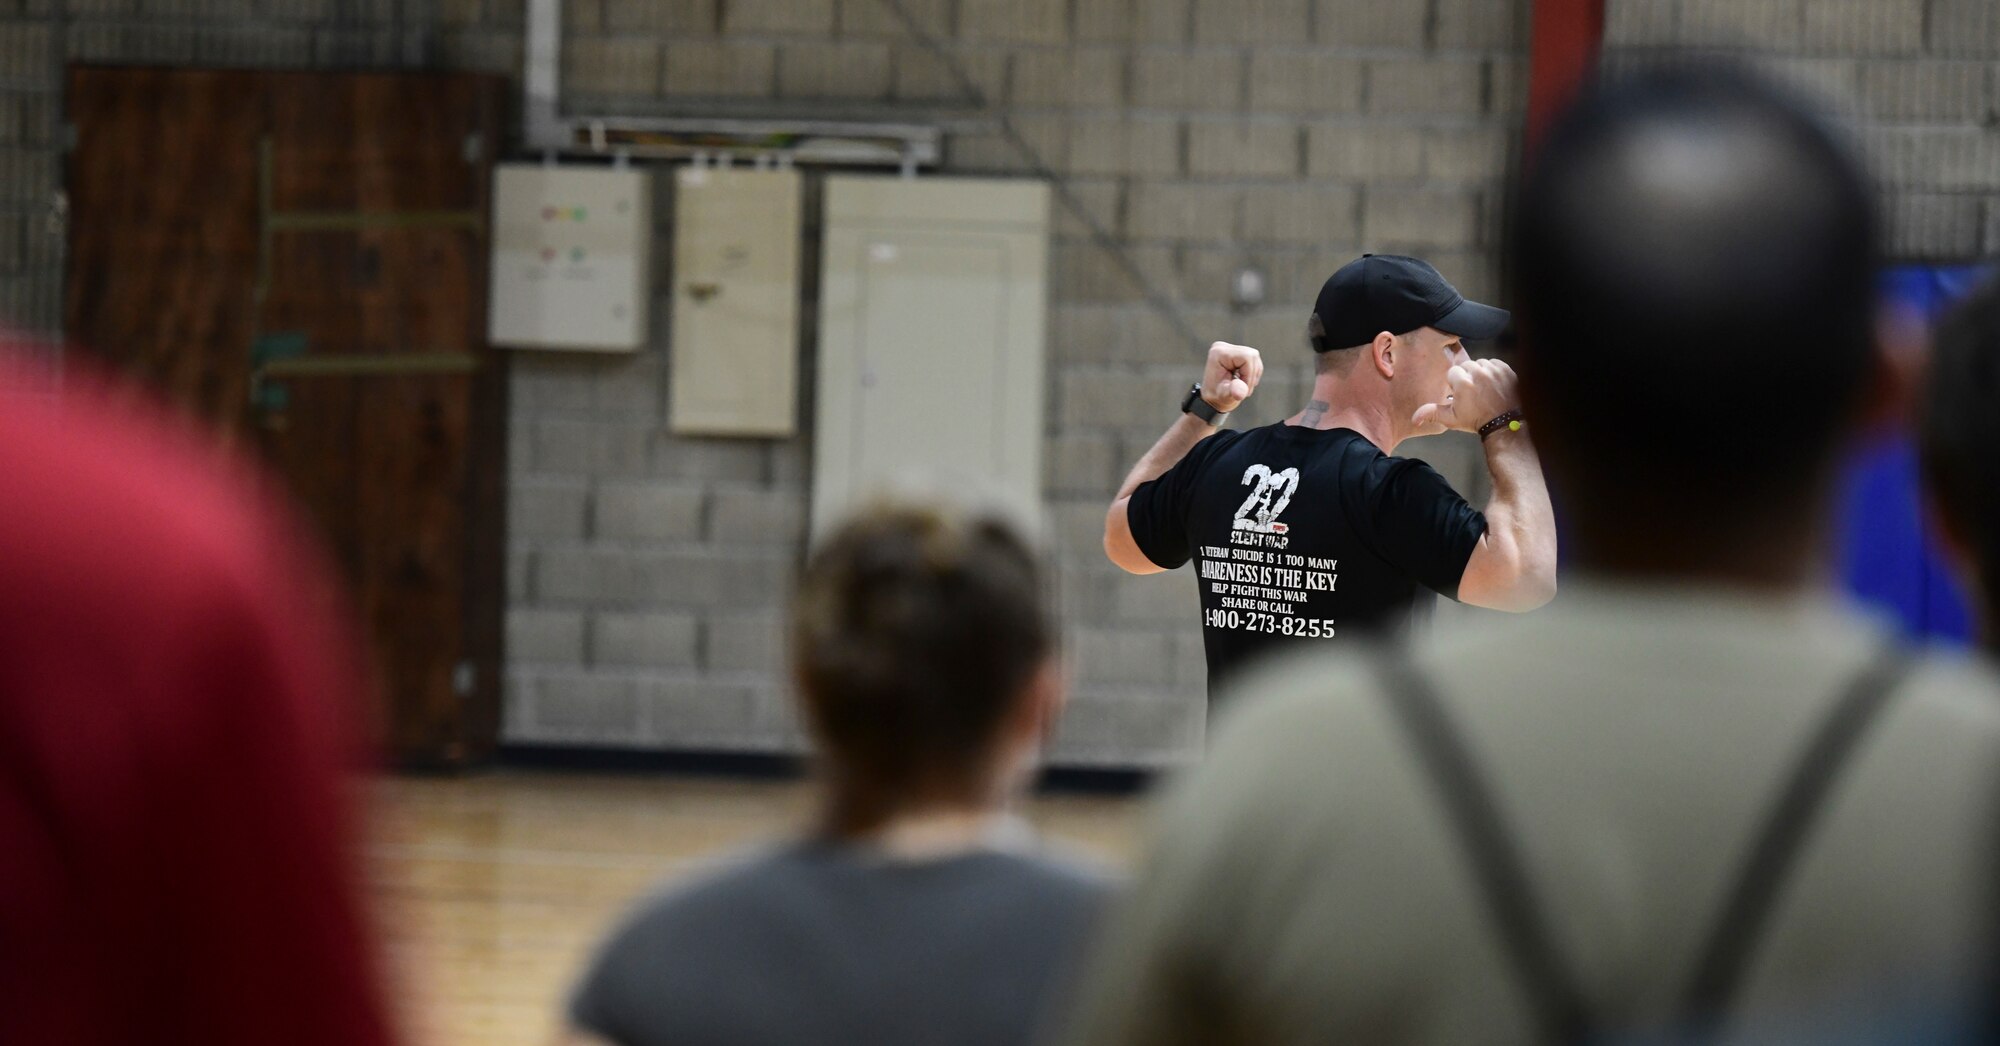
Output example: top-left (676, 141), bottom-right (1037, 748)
top-left (0, 0), bottom-right (1528, 766)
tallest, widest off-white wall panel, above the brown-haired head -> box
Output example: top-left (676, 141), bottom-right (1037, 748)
top-left (812, 178), bottom-right (1048, 536)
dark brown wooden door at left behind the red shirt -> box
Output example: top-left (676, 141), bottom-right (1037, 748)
top-left (66, 66), bottom-right (506, 766)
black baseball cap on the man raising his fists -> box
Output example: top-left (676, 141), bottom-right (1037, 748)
top-left (1312, 254), bottom-right (1508, 352)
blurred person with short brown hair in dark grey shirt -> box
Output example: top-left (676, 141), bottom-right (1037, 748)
top-left (568, 508), bottom-right (1108, 1046)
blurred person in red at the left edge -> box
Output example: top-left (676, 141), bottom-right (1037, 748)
top-left (0, 344), bottom-right (390, 1046)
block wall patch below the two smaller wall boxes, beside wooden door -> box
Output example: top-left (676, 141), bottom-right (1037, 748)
top-left (504, 326), bottom-right (806, 752)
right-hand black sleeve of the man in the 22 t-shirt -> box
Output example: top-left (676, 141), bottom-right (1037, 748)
top-left (1354, 458), bottom-right (1486, 600)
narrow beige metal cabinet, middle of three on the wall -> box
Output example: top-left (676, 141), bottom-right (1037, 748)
top-left (668, 166), bottom-right (802, 436)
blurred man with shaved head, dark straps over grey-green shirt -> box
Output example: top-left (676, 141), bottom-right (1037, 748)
top-left (1070, 66), bottom-right (2000, 1046)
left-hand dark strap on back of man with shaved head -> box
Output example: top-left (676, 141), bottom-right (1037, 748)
top-left (1376, 650), bottom-right (1592, 1042)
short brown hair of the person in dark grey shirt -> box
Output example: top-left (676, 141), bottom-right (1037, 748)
top-left (792, 504), bottom-right (1056, 828)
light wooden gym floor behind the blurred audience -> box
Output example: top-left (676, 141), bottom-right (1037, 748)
top-left (368, 770), bottom-right (1142, 1046)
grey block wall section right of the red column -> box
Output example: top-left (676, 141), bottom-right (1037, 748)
top-left (1604, 0), bottom-right (2000, 262)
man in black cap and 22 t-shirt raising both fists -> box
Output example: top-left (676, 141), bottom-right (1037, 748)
top-left (1104, 254), bottom-right (1556, 700)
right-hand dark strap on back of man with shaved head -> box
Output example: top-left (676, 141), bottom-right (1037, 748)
top-left (1682, 642), bottom-right (1914, 1038)
